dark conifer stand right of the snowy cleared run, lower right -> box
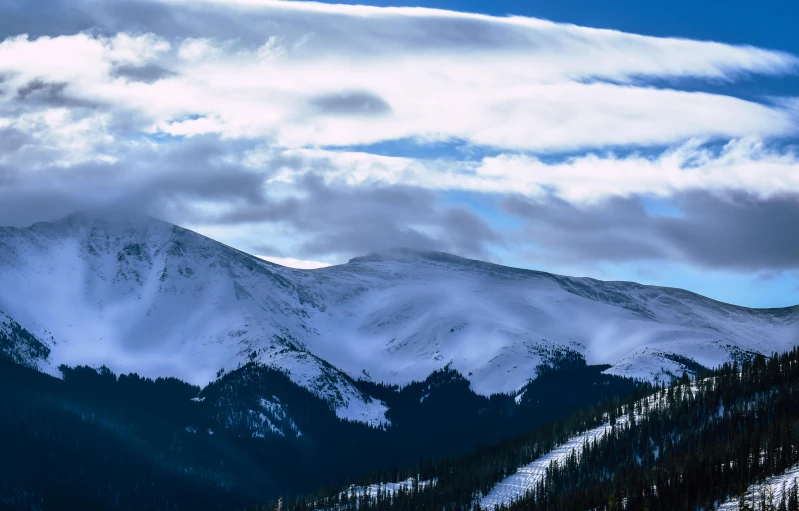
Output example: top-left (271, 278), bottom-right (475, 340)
top-left (510, 349), bottom-right (799, 511)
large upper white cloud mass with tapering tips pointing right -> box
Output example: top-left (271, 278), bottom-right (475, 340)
top-left (0, 0), bottom-right (797, 152)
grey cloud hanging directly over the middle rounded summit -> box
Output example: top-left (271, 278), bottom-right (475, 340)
top-left (215, 173), bottom-right (503, 258)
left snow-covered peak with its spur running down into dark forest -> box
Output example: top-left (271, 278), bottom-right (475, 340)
top-left (0, 215), bottom-right (385, 425)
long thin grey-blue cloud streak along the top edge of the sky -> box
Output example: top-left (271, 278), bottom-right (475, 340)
top-left (0, 0), bottom-right (580, 57)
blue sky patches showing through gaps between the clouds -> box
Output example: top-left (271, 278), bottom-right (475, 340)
top-left (304, 0), bottom-right (799, 307)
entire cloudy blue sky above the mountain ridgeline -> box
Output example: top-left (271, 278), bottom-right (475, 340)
top-left (0, 0), bottom-right (799, 307)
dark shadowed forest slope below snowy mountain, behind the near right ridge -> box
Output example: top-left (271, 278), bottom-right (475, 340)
top-left (0, 350), bottom-right (636, 510)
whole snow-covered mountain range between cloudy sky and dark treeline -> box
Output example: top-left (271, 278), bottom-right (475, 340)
top-left (0, 214), bottom-right (799, 425)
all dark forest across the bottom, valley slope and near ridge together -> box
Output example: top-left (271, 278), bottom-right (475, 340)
top-left (0, 349), bottom-right (799, 511)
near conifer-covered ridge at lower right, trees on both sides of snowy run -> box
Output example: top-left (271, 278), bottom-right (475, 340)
top-left (268, 349), bottom-right (799, 511)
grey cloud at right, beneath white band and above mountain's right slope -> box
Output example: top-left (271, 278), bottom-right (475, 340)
top-left (504, 192), bottom-right (799, 271)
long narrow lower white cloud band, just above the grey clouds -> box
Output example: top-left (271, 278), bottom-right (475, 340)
top-left (266, 138), bottom-right (799, 203)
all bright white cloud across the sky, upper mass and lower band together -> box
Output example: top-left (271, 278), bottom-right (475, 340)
top-left (0, 0), bottom-right (799, 218)
